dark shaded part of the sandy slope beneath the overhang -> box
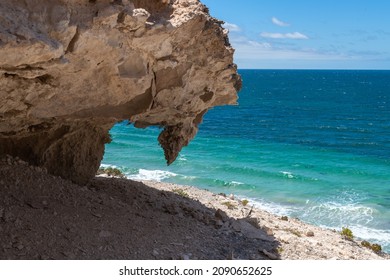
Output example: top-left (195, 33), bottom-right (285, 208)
top-left (0, 166), bottom-right (280, 260)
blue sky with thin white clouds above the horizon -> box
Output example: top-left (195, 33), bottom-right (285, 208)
top-left (201, 0), bottom-right (390, 69)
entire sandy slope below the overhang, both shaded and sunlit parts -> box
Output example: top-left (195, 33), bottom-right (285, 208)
top-left (0, 154), bottom-right (389, 260)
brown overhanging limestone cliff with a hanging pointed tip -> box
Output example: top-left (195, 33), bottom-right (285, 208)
top-left (0, 0), bottom-right (241, 183)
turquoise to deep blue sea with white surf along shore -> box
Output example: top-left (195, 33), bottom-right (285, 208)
top-left (103, 70), bottom-right (390, 252)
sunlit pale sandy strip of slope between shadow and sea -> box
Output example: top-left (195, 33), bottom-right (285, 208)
top-left (143, 181), bottom-right (390, 260)
